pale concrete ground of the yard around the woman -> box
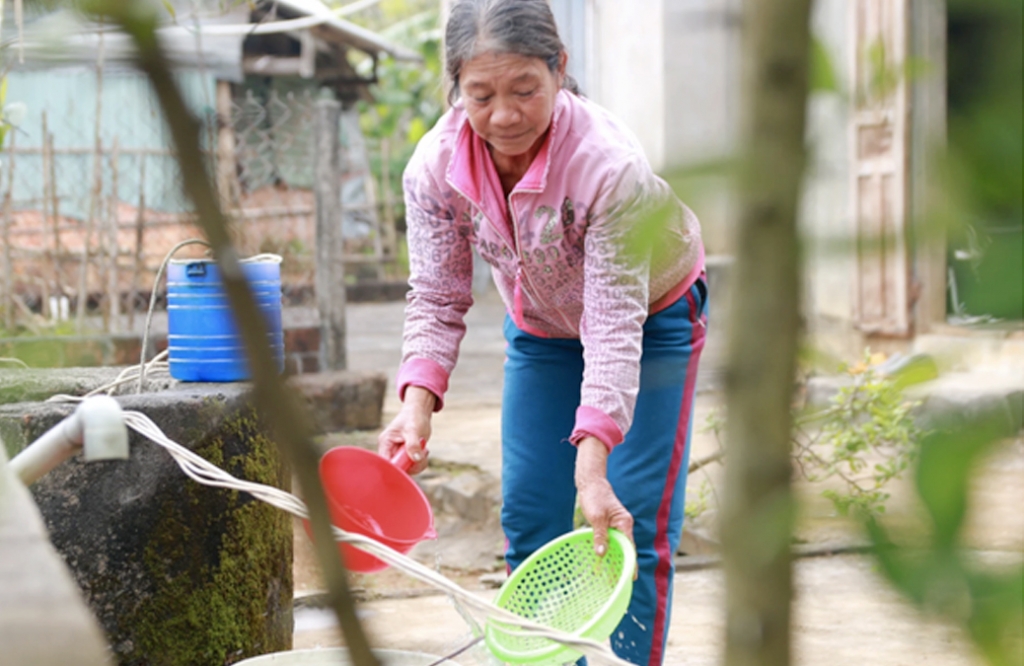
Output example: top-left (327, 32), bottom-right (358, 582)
top-left (295, 295), bottom-right (1024, 666)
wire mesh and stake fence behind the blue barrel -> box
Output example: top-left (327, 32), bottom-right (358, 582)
top-left (0, 72), bottom-right (394, 330)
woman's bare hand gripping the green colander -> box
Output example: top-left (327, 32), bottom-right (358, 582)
top-left (575, 436), bottom-right (633, 556)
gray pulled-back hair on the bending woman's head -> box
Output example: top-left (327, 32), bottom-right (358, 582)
top-left (444, 0), bottom-right (580, 103)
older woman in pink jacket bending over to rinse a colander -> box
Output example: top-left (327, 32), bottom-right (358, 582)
top-left (379, 0), bottom-right (707, 664)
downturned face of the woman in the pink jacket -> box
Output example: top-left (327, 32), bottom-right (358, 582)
top-left (459, 53), bottom-right (565, 157)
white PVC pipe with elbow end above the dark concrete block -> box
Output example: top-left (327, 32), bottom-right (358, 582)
top-left (10, 396), bottom-right (128, 486)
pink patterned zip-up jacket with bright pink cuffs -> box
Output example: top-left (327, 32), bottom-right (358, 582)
top-left (397, 90), bottom-right (703, 449)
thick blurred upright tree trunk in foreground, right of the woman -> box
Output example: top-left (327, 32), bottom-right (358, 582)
top-left (722, 0), bottom-right (811, 666)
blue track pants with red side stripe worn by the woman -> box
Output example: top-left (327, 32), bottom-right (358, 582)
top-left (502, 278), bottom-right (707, 666)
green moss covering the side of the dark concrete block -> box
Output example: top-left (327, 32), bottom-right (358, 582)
top-left (124, 408), bottom-right (292, 666)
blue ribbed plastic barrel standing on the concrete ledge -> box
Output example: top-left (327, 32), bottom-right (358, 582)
top-left (167, 254), bottom-right (285, 381)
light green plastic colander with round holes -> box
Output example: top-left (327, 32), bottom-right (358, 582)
top-left (485, 528), bottom-right (637, 666)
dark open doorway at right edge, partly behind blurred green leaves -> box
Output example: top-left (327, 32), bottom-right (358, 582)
top-left (946, 0), bottom-right (1024, 324)
